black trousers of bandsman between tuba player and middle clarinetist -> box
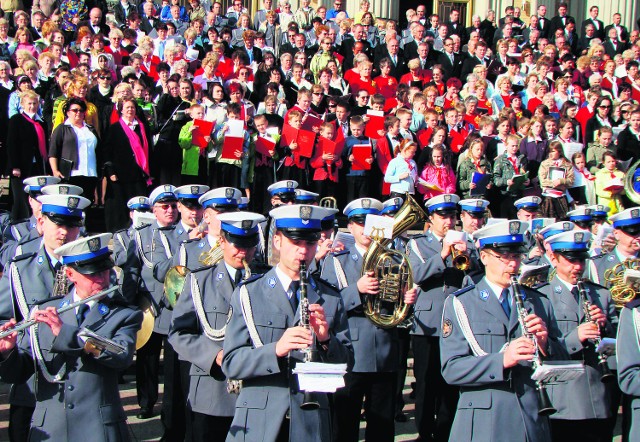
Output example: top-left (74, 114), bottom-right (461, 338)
top-left (411, 335), bottom-right (459, 441)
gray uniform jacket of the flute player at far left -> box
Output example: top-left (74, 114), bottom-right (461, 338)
top-left (0, 294), bottom-right (142, 442)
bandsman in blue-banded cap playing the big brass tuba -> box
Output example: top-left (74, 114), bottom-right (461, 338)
top-left (322, 198), bottom-right (416, 441)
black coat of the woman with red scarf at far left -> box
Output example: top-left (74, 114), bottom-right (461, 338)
top-left (7, 113), bottom-right (49, 175)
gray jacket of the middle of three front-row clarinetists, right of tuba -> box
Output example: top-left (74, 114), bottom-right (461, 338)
top-left (440, 279), bottom-right (566, 442)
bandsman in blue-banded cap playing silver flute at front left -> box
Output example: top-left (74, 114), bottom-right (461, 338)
top-left (0, 233), bottom-right (142, 442)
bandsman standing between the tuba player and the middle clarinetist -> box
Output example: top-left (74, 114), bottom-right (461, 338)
top-left (407, 194), bottom-right (467, 441)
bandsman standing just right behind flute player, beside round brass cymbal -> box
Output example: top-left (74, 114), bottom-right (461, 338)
top-left (122, 184), bottom-right (184, 436)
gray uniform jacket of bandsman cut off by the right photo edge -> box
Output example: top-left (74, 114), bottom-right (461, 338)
top-left (616, 299), bottom-right (640, 440)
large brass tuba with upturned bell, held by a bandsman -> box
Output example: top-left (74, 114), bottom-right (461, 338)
top-left (362, 194), bottom-right (427, 328)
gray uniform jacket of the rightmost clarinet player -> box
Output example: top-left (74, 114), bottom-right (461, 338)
top-left (537, 276), bottom-right (618, 420)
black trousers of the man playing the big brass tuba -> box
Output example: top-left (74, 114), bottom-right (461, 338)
top-left (333, 371), bottom-right (398, 442)
